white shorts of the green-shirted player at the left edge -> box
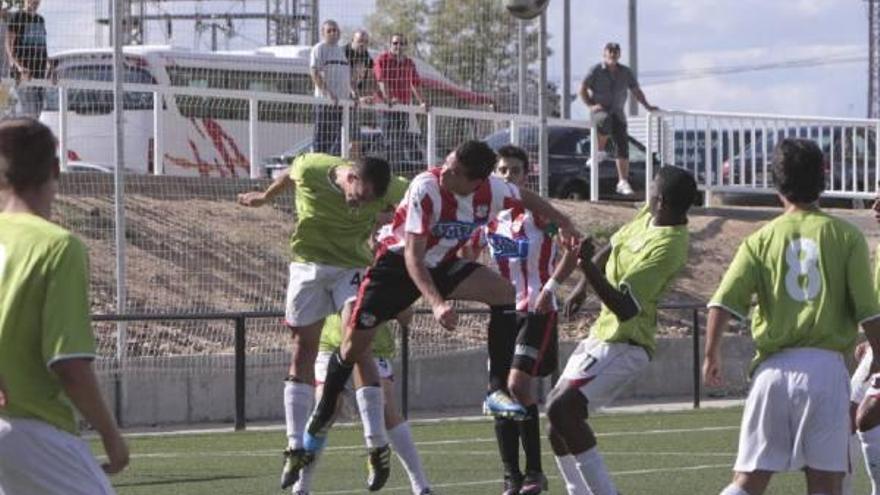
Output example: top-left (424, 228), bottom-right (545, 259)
top-left (0, 418), bottom-right (116, 495)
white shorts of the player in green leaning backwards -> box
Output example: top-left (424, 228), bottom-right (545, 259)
top-left (560, 337), bottom-right (650, 411)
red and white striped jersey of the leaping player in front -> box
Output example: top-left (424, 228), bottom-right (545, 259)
top-left (378, 168), bottom-right (521, 268)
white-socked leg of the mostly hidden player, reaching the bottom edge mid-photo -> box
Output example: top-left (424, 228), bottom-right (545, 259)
top-left (376, 359), bottom-right (432, 495)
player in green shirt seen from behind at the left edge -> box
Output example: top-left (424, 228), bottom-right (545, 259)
top-left (0, 118), bottom-right (129, 495)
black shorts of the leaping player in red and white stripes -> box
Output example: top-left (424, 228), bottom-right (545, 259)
top-left (353, 251), bottom-right (483, 330)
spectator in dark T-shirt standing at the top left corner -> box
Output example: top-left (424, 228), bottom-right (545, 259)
top-left (6, 0), bottom-right (49, 118)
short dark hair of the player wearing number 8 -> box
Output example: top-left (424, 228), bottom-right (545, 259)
top-left (773, 139), bottom-right (825, 203)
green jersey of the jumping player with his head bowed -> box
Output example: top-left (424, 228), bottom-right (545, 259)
top-left (289, 153), bottom-right (407, 268)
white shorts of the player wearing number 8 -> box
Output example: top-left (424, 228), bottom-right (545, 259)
top-left (734, 348), bottom-right (850, 473)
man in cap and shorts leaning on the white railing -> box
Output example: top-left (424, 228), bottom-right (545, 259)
top-left (580, 43), bottom-right (658, 196)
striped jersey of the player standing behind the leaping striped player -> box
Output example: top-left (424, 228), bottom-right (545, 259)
top-left (473, 207), bottom-right (558, 312)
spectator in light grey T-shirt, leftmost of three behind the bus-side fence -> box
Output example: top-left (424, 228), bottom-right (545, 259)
top-left (309, 20), bottom-right (352, 155)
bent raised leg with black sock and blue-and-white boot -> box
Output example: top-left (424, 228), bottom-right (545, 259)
top-left (444, 260), bottom-right (526, 419)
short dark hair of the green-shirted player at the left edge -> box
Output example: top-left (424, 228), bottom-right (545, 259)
top-left (0, 117), bottom-right (58, 192)
